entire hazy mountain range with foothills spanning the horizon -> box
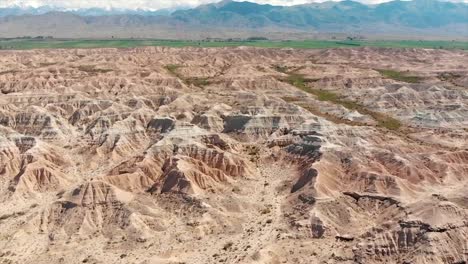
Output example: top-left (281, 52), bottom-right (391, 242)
top-left (0, 0), bottom-right (468, 38)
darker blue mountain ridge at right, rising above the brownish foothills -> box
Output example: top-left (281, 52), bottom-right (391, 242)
top-left (172, 0), bottom-right (468, 29)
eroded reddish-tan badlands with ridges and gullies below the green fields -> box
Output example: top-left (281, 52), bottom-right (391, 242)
top-left (0, 47), bottom-right (468, 264)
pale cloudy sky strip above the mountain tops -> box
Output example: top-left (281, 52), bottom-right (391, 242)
top-left (0, 0), bottom-right (468, 10)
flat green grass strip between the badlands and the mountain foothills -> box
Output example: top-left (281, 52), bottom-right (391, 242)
top-left (0, 39), bottom-right (468, 50)
